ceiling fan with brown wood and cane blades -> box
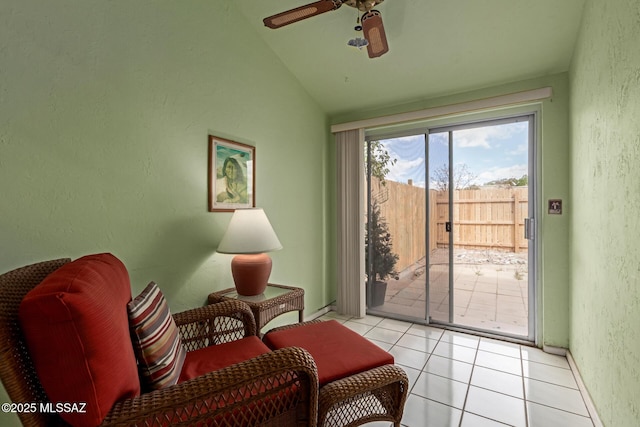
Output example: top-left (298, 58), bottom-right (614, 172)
top-left (263, 0), bottom-right (389, 58)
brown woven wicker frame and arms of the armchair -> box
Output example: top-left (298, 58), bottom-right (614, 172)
top-left (0, 258), bottom-right (318, 426)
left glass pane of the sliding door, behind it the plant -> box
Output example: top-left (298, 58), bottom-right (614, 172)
top-left (365, 135), bottom-right (427, 319)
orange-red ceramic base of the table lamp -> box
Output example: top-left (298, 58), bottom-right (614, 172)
top-left (231, 253), bottom-right (271, 296)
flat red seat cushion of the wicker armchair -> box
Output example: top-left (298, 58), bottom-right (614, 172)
top-left (178, 336), bottom-right (271, 383)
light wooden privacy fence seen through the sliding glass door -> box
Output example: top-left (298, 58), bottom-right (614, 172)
top-left (371, 181), bottom-right (528, 271)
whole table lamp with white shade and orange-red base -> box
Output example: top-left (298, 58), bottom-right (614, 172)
top-left (218, 208), bottom-right (282, 296)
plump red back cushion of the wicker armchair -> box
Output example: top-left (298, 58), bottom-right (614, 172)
top-left (19, 254), bottom-right (140, 426)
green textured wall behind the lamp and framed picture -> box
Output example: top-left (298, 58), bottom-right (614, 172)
top-left (0, 0), bottom-right (334, 425)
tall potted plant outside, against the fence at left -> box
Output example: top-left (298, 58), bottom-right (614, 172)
top-left (365, 202), bottom-right (398, 307)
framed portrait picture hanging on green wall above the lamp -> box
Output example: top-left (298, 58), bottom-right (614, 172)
top-left (208, 135), bottom-right (256, 212)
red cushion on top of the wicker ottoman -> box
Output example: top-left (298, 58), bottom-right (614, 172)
top-left (263, 320), bottom-right (394, 385)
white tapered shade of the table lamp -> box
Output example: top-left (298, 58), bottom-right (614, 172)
top-left (218, 208), bottom-right (282, 254)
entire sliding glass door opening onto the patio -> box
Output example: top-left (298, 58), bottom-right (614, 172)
top-left (365, 115), bottom-right (535, 340)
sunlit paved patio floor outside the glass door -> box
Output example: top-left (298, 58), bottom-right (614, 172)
top-left (374, 249), bottom-right (528, 337)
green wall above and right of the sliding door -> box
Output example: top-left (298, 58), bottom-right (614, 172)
top-left (330, 73), bottom-right (569, 348)
